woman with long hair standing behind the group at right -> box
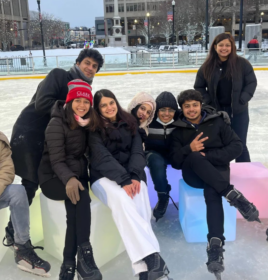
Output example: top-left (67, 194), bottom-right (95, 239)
top-left (194, 33), bottom-right (257, 162)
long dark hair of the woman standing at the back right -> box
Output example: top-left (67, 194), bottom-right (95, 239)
top-left (202, 33), bottom-right (238, 81)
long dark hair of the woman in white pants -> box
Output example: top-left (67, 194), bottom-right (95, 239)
top-left (93, 89), bottom-right (137, 135)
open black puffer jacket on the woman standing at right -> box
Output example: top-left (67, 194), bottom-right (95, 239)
top-left (194, 57), bottom-right (257, 115)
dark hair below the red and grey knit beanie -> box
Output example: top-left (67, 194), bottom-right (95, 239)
top-left (65, 100), bottom-right (100, 131)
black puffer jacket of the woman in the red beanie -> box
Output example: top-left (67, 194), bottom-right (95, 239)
top-left (38, 101), bottom-right (88, 186)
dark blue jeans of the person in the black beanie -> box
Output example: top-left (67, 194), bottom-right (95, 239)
top-left (146, 151), bottom-right (171, 193)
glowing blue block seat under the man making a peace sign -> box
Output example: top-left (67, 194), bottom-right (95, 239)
top-left (179, 179), bottom-right (236, 242)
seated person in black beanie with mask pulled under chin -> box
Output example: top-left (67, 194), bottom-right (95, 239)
top-left (145, 91), bottom-right (178, 221)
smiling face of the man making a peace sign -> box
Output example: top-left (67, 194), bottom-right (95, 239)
top-left (182, 100), bottom-right (202, 124)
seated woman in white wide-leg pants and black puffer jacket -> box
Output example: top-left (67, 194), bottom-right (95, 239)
top-left (88, 90), bottom-right (168, 280)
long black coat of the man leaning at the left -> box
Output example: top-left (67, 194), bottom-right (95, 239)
top-left (10, 68), bottom-right (88, 183)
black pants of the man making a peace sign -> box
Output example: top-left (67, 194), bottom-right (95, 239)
top-left (182, 152), bottom-right (232, 244)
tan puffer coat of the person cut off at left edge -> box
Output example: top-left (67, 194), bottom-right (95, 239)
top-left (0, 131), bottom-right (15, 196)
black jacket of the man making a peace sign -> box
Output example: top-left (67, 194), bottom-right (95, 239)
top-left (170, 113), bottom-right (243, 172)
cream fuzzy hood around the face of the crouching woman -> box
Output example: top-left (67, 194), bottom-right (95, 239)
top-left (127, 92), bottom-right (156, 135)
